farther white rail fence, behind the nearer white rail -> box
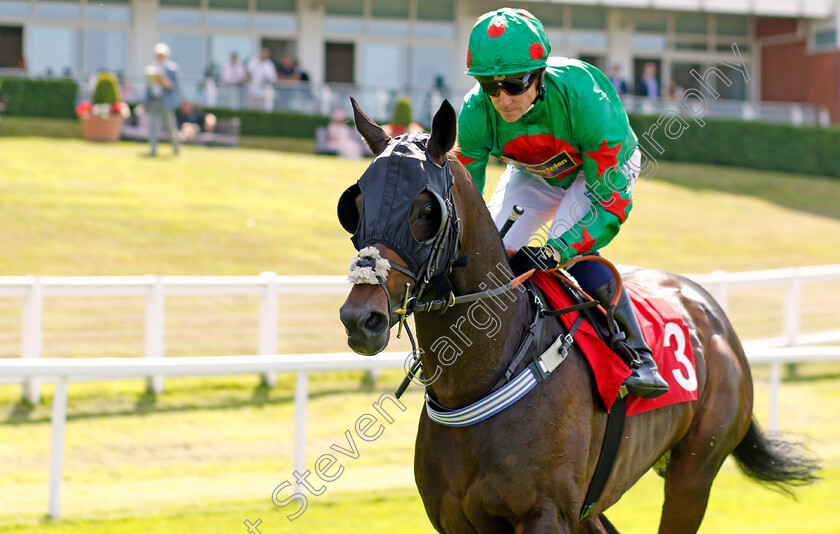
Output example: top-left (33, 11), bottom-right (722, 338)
top-left (0, 264), bottom-right (840, 404)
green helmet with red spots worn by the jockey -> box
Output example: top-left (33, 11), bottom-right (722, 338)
top-left (467, 7), bottom-right (551, 76)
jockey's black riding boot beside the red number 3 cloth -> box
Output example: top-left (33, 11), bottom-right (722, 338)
top-left (592, 280), bottom-right (668, 399)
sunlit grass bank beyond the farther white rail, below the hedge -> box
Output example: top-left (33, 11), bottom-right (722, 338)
top-left (0, 137), bottom-right (840, 275)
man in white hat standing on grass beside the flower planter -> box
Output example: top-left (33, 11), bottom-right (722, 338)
top-left (146, 43), bottom-right (181, 156)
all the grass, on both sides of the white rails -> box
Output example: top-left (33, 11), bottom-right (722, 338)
top-left (0, 136), bottom-right (840, 534)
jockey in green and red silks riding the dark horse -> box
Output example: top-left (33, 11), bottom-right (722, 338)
top-left (458, 8), bottom-right (668, 398)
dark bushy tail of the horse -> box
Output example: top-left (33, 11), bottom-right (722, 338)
top-left (732, 419), bottom-right (820, 496)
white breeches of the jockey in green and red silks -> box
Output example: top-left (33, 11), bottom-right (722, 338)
top-left (487, 150), bottom-right (641, 250)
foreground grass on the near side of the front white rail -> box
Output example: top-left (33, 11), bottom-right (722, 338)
top-left (0, 364), bottom-right (840, 534)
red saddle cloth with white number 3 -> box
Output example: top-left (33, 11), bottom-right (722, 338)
top-left (531, 271), bottom-right (697, 415)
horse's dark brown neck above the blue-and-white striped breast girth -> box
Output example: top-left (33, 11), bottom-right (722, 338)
top-left (415, 170), bottom-right (532, 407)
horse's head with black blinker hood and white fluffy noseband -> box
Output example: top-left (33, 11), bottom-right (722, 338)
top-left (338, 100), bottom-right (460, 355)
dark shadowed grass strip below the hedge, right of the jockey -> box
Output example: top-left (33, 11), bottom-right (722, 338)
top-left (651, 162), bottom-right (840, 220)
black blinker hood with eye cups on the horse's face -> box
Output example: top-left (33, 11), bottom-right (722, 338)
top-left (338, 133), bottom-right (458, 282)
